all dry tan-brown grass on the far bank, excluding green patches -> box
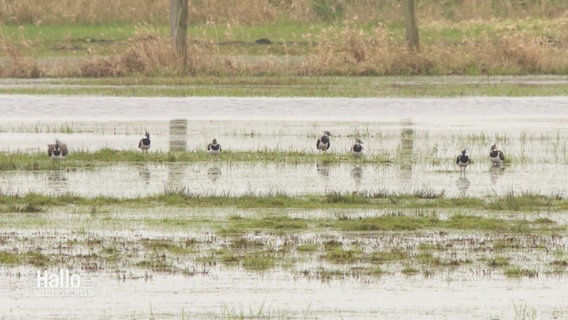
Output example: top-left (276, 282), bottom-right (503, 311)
top-left (0, 0), bottom-right (568, 77)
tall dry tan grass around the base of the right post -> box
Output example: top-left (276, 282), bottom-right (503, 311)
top-left (298, 22), bottom-right (568, 75)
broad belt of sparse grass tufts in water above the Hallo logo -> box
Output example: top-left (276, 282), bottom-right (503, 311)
top-left (0, 206), bottom-right (567, 281)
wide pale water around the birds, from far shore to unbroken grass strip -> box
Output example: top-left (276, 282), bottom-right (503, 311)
top-left (0, 95), bottom-right (568, 197)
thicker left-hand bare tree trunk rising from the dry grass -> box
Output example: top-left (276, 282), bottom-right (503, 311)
top-left (170, 0), bottom-right (189, 72)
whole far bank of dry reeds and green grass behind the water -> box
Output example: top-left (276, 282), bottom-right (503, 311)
top-left (0, 0), bottom-right (568, 78)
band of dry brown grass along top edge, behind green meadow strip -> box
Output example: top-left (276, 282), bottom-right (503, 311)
top-left (4, 0), bottom-right (568, 25)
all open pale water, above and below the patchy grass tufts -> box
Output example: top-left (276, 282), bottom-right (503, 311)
top-left (0, 96), bottom-right (568, 319)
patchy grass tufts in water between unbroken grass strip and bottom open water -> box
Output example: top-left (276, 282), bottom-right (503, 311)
top-left (0, 199), bottom-right (567, 281)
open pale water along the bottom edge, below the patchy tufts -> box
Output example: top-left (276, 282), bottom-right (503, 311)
top-left (0, 270), bottom-right (568, 319)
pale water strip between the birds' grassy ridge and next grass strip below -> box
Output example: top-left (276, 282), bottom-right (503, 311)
top-left (0, 161), bottom-right (568, 198)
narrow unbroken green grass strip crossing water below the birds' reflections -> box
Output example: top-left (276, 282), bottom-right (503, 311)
top-left (0, 188), bottom-right (568, 214)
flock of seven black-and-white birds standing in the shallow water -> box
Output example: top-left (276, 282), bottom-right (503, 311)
top-left (47, 131), bottom-right (505, 172)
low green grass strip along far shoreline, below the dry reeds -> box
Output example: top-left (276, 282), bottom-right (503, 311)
top-left (0, 76), bottom-right (567, 97)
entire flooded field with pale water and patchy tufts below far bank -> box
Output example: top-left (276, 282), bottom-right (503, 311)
top-left (0, 96), bottom-right (568, 319)
